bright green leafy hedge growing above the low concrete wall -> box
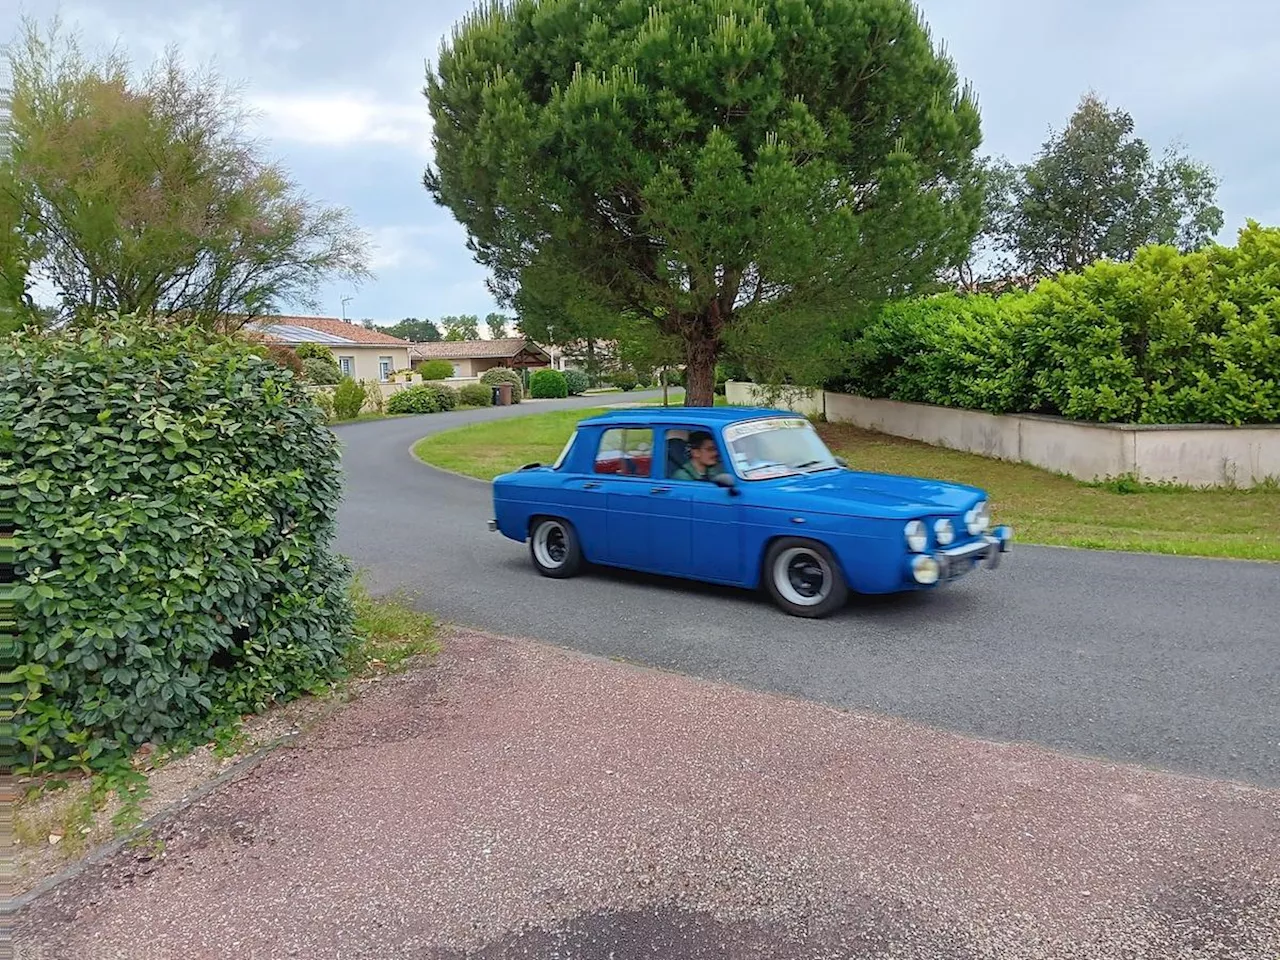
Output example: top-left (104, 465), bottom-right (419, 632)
top-left (831, 223), bottom-right (1280, 425)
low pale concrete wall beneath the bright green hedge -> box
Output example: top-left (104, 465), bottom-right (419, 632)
top-left (726, 383), bottom-right (1280, 488)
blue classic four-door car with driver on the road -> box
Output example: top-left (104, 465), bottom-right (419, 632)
top-left (489, 407), bottom-right (1012, 617)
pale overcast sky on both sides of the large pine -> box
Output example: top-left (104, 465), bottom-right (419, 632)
top-left (0, 0), bottom-right (1280, 323)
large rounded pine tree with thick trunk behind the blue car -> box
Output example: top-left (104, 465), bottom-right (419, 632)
top-left (424, 0), bottom-right (980, 406)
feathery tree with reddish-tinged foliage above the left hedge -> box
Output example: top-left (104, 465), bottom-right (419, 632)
top-left (0, 19), bottom-right (369, 326)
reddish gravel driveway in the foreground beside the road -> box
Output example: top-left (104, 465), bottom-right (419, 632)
top-left (18, 634), bottom-right (1280, 960)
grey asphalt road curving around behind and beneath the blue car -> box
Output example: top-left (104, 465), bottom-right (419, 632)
top-left (337, 394), bottom-right (1280, 787)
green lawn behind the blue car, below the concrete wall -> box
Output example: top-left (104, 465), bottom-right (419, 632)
top-left (413, 407), bottom-right (1280, 561)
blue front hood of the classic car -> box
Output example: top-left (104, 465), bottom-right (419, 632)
top-left (762, 470), bottom-right (986, 518)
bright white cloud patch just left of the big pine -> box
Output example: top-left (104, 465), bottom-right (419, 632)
top-left (250, 92), bottom-right (431, 156)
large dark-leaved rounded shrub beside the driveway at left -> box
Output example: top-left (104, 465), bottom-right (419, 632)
top-left (0, 319), bottom-right (352, 769)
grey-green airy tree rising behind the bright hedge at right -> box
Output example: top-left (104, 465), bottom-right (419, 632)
top-left (984, 93), bottom-right (1222, 279)
